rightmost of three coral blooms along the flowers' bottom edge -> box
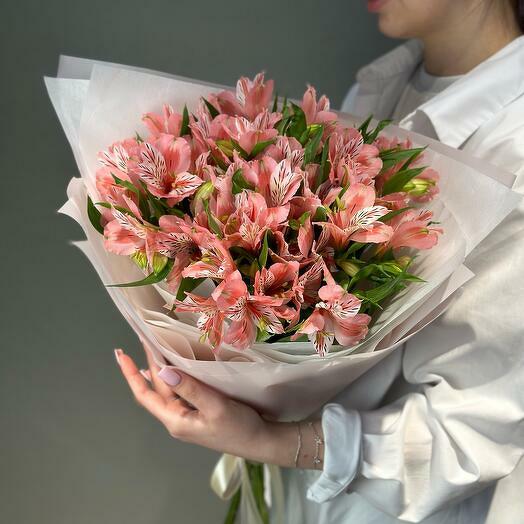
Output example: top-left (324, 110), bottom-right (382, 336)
top-left (292, 268), bottom-right (371, 356)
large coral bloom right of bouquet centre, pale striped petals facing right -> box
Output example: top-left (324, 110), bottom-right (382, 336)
top-left (318, 184), bottom-right (393, 250)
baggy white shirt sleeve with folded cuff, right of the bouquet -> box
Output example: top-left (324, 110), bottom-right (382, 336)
top-left (308, 137), bottom-right (524, 522)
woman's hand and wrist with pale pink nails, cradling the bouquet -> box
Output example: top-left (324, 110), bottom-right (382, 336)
top-left (115, 346), bottom-right (322, 467)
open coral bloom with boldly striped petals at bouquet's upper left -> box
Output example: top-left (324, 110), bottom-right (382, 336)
top-left (136, 135), bottom-right (203, 206)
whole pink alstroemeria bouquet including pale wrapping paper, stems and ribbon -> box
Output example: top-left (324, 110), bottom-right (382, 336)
top-left (46, 58), bottom-right (518, 518)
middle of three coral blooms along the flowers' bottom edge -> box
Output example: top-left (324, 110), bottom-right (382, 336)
top-left (211, 271), bottom-right (284, 349)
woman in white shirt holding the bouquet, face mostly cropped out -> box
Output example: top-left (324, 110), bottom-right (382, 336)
top-left (116, 0), bottom-right (524, 524)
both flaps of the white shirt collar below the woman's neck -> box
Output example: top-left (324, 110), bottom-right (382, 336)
top-left (357, 36), bottom-right (524, 147)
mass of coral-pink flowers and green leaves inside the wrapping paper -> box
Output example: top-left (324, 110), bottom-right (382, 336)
top-left (87, 70), bottom-right (442, 356)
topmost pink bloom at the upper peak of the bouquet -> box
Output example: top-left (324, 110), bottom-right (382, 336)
top-left (217, 73), bottom-right (273, 120)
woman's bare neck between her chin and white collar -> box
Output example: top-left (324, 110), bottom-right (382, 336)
top-left (421, 7), bottom-right (521, 76)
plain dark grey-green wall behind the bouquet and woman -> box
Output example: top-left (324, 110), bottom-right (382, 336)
top-left (0, 0), bottom-right (394, 524)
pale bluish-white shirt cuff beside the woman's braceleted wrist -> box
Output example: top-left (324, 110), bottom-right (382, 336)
top-left (307, 404), bottom-right (362, 503)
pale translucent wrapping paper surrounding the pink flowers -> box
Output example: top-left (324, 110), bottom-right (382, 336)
top-left (46, 57), bottom-right (520, 420)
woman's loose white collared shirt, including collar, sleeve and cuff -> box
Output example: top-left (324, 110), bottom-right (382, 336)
top-left (283, 37), bottom-right (524, 524)
